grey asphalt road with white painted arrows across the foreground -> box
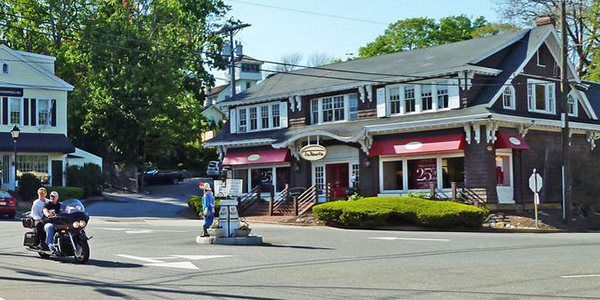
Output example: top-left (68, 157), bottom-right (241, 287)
top-left (0, 181), bottom-right (600, 300)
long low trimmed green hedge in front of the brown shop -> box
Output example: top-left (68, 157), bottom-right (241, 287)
top-left (313, 197), bottom-right (488, 228)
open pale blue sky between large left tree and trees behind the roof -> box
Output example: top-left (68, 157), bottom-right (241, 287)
top-left (215, 0), bottom-right (499, 84)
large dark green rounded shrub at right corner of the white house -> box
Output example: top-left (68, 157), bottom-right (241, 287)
top-left (65, 163), bottom-right (106, 198)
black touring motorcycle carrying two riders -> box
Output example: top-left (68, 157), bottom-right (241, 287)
top-left (21, 199), bottom-right (91, 264)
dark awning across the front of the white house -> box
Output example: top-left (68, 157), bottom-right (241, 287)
top-left (0, 132), bottom-right (75, 153)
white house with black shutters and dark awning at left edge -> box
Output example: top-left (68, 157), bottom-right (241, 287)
top-left (0, 45), bottom-right (101, 189)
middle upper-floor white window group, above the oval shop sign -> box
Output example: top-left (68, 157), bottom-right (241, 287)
top-left (310, 95), bottom-right (350, 124)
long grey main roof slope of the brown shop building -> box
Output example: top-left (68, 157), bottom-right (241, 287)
top-left (226, 30), bottom-right (529, 102)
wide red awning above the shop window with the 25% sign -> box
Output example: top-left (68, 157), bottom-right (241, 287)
top-left (369, 134), bottom-right (465, 156)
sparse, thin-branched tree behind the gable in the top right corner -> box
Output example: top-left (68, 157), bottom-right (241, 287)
top-left (499, 0), bottom-right (600, 77)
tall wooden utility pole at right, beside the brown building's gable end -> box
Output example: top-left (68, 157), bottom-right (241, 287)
top-left (560, 0), bottom-right (577, 224)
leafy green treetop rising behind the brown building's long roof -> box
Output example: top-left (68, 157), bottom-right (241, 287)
top-left (358, 15), bottom-right (487, 57)
